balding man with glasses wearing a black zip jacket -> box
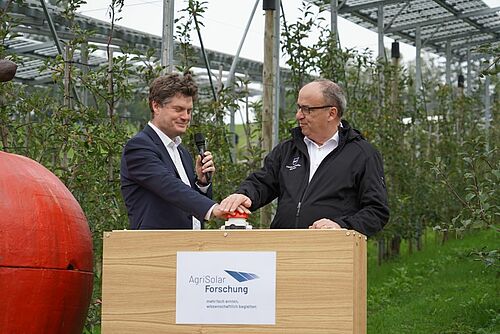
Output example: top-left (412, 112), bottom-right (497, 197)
top-left (221, 79), bottom-right (389, 236)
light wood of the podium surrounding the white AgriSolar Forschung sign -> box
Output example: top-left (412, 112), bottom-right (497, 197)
top-left (102, 230), bottom-right (366, 334)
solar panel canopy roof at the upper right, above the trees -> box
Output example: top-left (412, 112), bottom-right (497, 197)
top-left (309, 0), bottom-right (500, 59)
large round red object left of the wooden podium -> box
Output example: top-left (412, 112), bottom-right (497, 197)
top-left (0, 152), bottom-right (94, 334)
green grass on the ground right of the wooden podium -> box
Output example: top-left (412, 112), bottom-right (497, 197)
top-left (368, 231), bottom-right (500, 334)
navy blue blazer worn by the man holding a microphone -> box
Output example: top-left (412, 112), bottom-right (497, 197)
top-left (120, 125), bottom-right (215, 230)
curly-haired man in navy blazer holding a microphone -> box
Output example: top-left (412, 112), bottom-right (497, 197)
top-left (120, 74), bottom-right (224, 230)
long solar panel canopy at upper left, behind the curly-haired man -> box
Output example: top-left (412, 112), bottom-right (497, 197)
top-left (0, 0), bottom-right (289, 93)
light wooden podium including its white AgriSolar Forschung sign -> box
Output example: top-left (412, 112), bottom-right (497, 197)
top-left (102, 230), bottom-right (366, 334)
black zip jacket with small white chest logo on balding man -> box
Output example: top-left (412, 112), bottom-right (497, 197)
top-left (236, 121), bottom-right (389, 236)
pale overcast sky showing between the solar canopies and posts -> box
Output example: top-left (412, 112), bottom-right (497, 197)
top-left (79, 0), bottom-right (500, 122)
